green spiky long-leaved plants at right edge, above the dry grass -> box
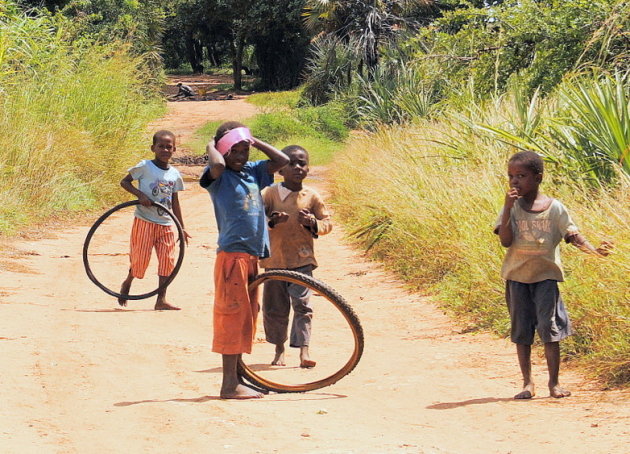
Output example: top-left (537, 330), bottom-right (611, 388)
top-left (460, 73), bottom-right (630, 185)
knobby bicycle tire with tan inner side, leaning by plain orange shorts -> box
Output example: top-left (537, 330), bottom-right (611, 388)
top-left (238, 270), bottom-right (364, 393)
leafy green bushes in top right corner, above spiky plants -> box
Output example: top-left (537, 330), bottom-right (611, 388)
top-left (405, 0), bottom-right (630, 94)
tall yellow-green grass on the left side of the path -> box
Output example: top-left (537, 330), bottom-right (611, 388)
top-left (0, 4), bottom-right (160, 233)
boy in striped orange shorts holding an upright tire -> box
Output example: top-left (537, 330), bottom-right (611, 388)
top-left (118, 130), bottom-right (190, 311)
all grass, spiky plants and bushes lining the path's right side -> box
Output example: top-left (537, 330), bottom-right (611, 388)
top-left (302, 0), bottom-right (630, 385)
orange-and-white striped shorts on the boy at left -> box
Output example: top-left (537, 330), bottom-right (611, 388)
top-left (129, 217), bottom-right (175, 279)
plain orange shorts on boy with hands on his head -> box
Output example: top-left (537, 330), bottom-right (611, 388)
top-left (212, 251), bottom-right (259, 355)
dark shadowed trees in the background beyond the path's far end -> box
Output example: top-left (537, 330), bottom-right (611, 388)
top-left (163, 0), bottom-right (309, 89)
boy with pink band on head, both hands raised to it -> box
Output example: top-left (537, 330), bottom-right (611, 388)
top-left (199, 122), bottom-right (289, 399)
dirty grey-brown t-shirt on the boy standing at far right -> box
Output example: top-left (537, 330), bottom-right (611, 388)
top-left (495, 199), bottom-right (578, 284)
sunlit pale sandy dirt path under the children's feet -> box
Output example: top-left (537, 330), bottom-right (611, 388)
top-left (0, 96), bottom-right (630, 454)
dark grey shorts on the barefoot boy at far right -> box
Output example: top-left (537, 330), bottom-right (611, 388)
top-left (505, 280), bottom-right (573, 345)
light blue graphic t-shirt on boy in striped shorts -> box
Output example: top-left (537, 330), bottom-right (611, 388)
top-left (129, 159), bottom-right (184, 225)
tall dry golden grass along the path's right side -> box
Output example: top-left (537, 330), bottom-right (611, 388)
top-left (332, 90), bottom-right (630, 384)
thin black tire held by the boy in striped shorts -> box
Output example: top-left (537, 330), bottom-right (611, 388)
top-left (83, 200), bottom-right (186, 300)
